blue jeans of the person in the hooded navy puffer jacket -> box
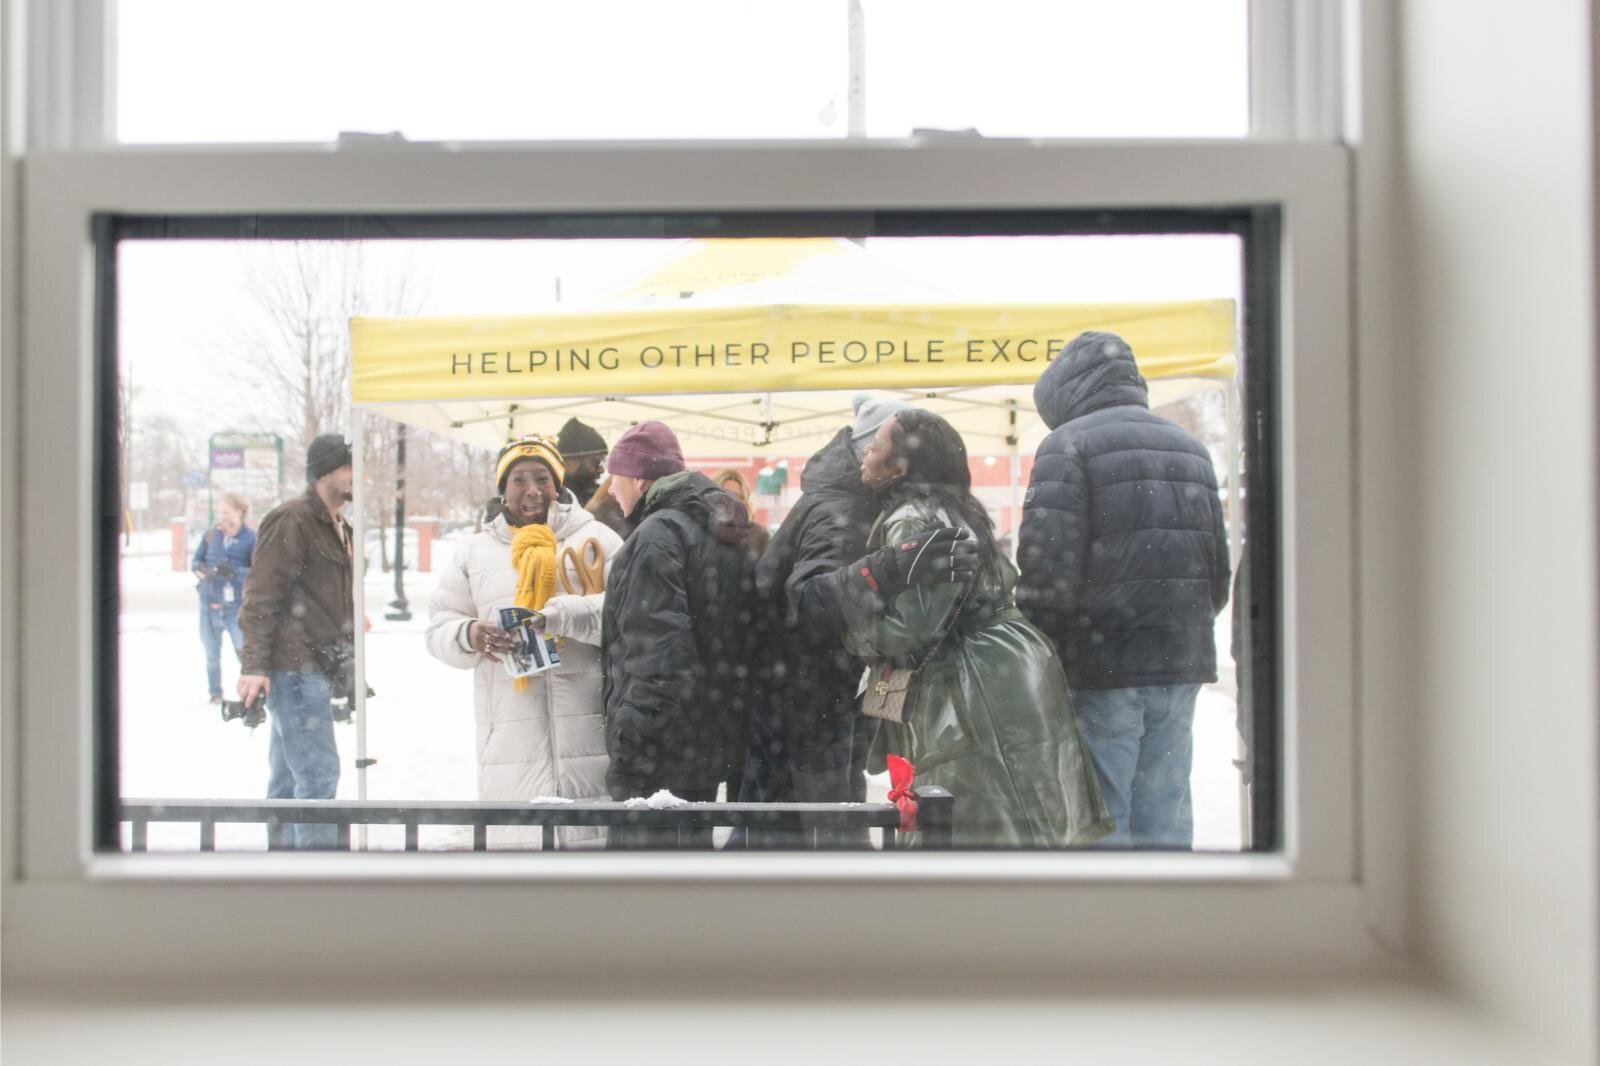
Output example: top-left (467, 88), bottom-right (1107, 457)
top-left (1072, 685), bottom-right (1200, 848)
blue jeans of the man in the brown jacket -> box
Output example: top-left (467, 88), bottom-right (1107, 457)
top-left (267, 671), bottom-right (339, 848)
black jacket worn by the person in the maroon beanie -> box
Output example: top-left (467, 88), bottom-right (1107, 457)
top-left (602, 471), bottom-right (754, 799)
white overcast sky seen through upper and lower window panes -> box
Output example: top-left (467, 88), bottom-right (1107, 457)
top-left (117, 0), bottom-right (1248, 440)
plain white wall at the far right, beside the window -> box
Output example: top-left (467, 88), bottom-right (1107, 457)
top-left (1395, 0), bottom-right (1597, 1061)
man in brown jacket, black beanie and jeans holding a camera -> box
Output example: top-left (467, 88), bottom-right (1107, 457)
top-left (238, 434), bottom-right (355, 848)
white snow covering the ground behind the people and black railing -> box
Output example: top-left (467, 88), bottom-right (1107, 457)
top-left (120, 530), bottom-right (1242, 850)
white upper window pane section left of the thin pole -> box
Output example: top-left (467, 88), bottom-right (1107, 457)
top-left (117, 0), bottom-right (845, 142)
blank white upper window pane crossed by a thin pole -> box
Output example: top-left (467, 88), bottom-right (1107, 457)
top-left (114, 0), bottom-right (1248, 142)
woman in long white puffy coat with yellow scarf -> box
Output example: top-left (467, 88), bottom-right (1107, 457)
top-left (427, 437), bottom-right (622, 847)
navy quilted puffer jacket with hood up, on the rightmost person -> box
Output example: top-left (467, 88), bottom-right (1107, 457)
top-left (1016, 333), bottom-right (1229, 688)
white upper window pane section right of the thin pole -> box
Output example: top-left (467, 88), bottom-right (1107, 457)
top-left (866, 0), bottom-right (1250, 138)
